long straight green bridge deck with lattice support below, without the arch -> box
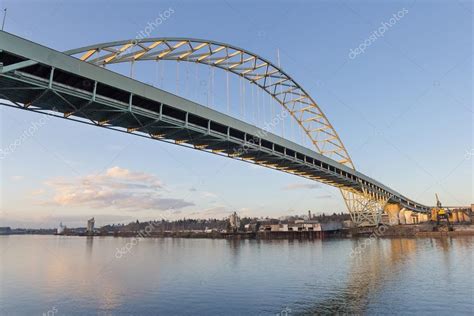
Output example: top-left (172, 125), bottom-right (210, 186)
top-left (0, 33), bottom-right (430, 224)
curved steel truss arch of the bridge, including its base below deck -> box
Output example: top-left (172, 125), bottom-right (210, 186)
top-left (65, 37), bottom-right (387, 225)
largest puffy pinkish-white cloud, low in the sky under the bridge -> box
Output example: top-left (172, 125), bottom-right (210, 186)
top-left (39, 167), bottom-right (194, 211)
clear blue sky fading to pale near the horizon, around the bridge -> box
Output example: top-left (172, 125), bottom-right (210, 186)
top-left (0, 0), bottom-right (474, 228)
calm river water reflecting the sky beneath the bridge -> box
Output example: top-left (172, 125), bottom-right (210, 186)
top-left (0, 235), bottom-right (474, 316)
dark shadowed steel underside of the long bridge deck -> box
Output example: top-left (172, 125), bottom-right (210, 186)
top-left (0, 65), bottom-right (360, 192)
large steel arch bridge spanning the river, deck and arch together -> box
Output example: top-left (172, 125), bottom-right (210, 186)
top-left (0, 31), bottom-right (432, 225)
